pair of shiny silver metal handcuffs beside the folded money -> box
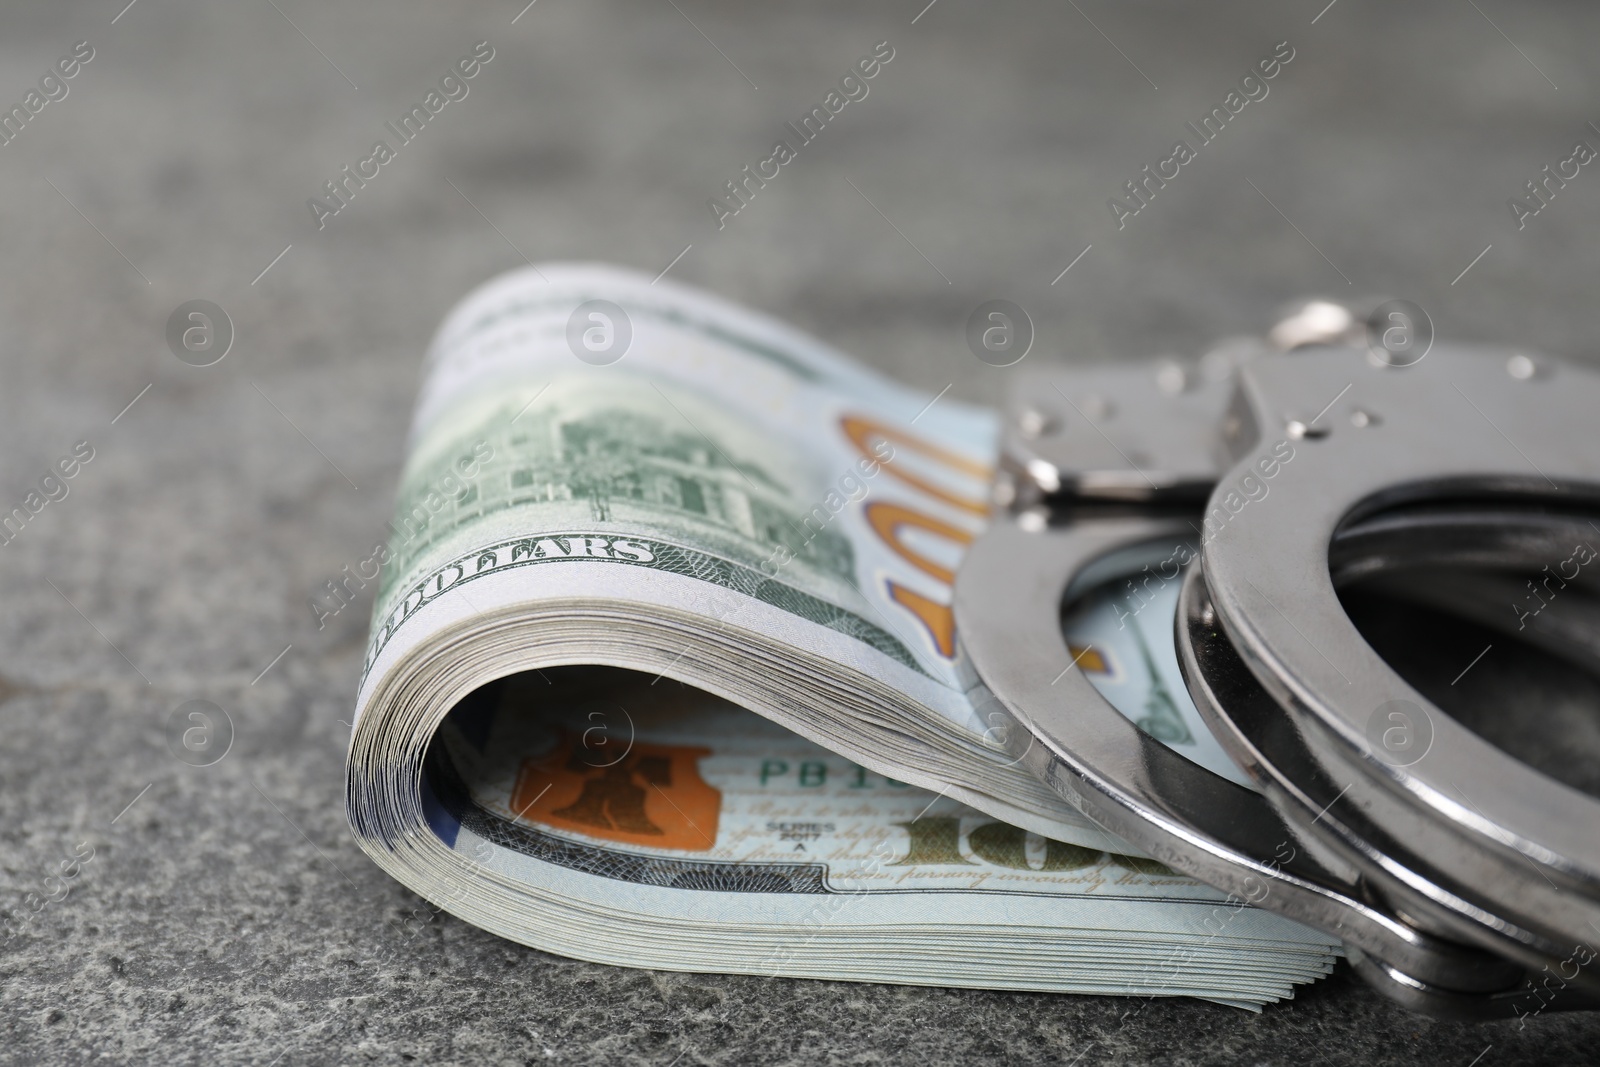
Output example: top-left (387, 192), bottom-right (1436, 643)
top-left (955, 306), bottom-right (1600, 1019)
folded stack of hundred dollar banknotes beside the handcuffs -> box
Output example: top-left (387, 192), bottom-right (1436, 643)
top-left (347, 264), bottom-right (1339, 1008)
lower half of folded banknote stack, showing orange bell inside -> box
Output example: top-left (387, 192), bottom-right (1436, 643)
top-left (396, 667), bottom-right (1333, 1008)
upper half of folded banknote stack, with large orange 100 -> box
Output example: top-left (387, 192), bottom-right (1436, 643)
top-left (352, 264), bottom-right (1126, 851)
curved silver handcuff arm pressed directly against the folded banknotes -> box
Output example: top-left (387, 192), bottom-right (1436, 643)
top-left (955, 517), bottom-right (1520, 995)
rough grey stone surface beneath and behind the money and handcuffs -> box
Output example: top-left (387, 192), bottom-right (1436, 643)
top-left (0, 0), bottom-right (1600, 1067)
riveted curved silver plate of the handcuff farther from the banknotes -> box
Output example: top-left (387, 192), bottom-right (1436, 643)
top-left (1202, 349), bottom-right (1600, 992)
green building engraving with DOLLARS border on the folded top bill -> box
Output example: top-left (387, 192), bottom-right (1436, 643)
top-left (366, 367), bottom-right (902, 687)
